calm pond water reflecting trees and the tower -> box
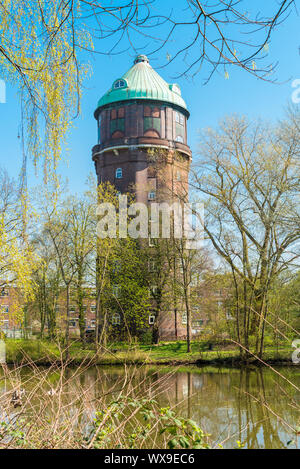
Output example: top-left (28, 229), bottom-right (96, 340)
top-left (0, 366), bottom-right (300, 449)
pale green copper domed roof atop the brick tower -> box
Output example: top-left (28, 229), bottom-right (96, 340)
top-left (97, 55), bottom-right (187, 115)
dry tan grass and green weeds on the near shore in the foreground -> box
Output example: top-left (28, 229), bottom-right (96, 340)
top-left (0, 350), bottom-right (208, 449)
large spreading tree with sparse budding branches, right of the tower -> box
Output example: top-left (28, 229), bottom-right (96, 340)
top-left (193, 117), bottom-right (300, 357)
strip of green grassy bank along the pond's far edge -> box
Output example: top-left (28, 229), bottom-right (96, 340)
top-left (6, 339), bottom-right (293, 365)
